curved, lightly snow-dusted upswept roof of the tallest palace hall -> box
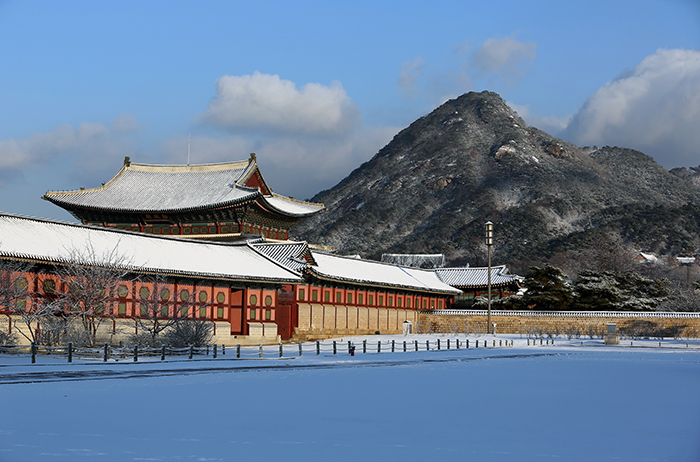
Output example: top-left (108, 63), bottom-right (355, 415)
top-left (44, 158), bottom-right (323, 217)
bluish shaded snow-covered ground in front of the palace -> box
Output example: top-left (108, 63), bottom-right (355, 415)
top-left (0, 335), bottom-right (700, 462)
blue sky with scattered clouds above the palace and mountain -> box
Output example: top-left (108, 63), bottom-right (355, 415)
top-left (0, 0), bottom-right (700, 219)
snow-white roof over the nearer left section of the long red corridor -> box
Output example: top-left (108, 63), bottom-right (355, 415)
top-left (0, 214), bottom-right (302, 283)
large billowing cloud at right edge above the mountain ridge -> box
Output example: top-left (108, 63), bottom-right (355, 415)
top-left (562, 49), bottom-right (700, 168)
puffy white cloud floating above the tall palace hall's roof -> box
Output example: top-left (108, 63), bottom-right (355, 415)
top-left (200, 72), bottom-right (361, 136)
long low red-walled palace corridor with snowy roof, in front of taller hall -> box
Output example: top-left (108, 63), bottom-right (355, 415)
top-left (0, 213), bottom-right (461, 345)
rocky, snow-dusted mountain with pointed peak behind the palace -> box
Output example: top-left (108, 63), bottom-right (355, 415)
top-left (294, 92), bottom-right (700, 264)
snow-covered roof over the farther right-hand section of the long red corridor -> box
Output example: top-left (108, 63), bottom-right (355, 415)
top-left (306, 249), bottom-right (461, 294)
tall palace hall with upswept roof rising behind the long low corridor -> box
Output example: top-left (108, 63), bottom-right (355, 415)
top-left (43, 154), bottom-right (324, 241)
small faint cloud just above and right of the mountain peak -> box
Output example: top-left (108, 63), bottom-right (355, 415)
top-left (471, 37), bottom-right (537, 83)
